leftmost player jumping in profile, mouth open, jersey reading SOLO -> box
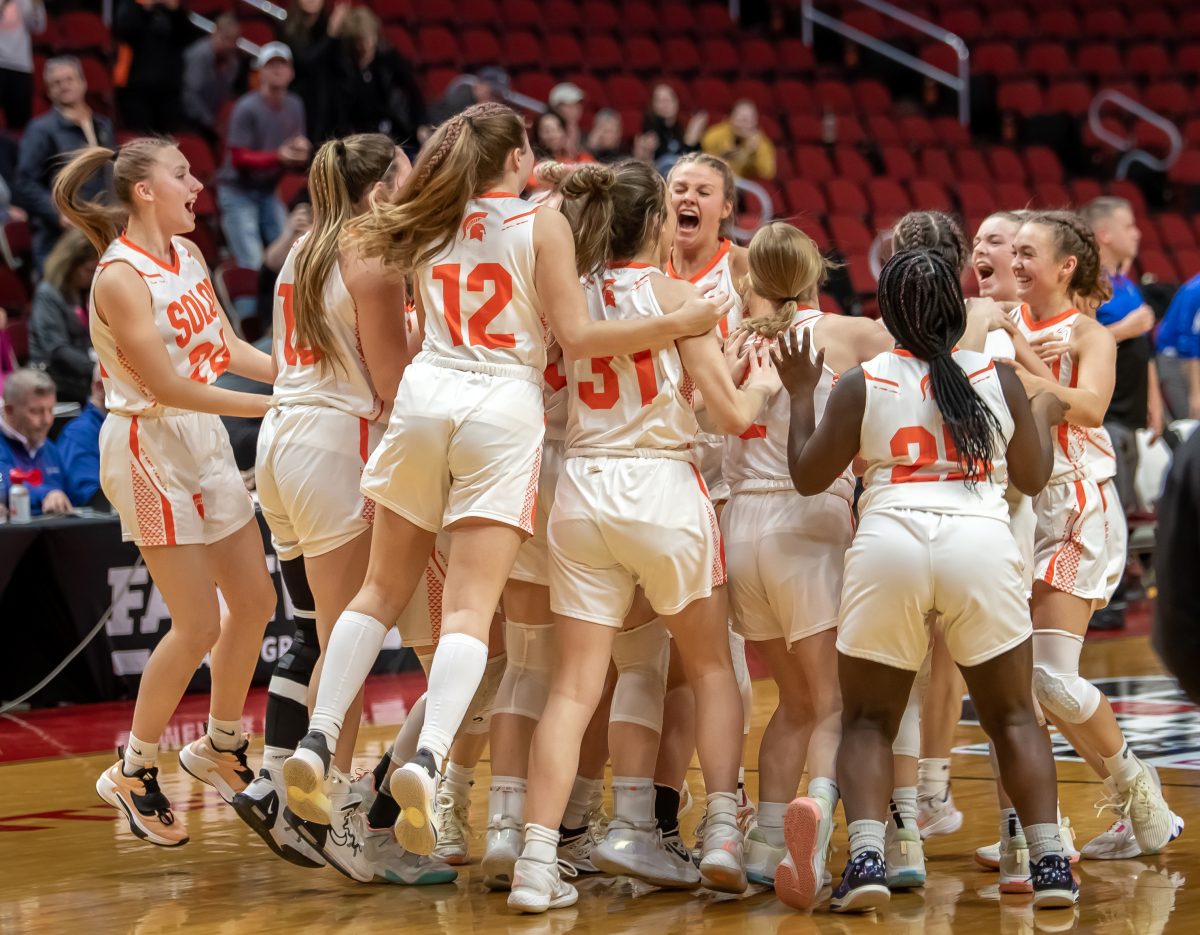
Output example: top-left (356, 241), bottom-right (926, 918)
top-left (53, 138), bottom-right (275, 847)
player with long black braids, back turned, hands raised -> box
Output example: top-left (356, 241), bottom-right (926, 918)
top-left (780, 251), bottom-right (1079, 912)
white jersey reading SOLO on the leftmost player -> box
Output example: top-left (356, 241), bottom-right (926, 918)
top-left (89, 234), bottom-right (229, 415)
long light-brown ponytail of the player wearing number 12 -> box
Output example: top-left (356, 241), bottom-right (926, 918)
top-left (355, 102), bottom-right (527, 275)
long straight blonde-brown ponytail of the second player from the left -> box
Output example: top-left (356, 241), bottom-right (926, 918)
top-left (294, 133), bottom-right (396, 365)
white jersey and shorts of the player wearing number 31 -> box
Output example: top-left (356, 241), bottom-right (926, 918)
top-left (548, 264), bottom-right (725, 627)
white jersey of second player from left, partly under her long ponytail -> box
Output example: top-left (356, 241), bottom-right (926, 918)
top-left (271, 234), bottom-right (383, 421)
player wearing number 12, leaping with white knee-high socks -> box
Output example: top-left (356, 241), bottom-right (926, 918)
top-left (284, 103), bottom-right (725, 855)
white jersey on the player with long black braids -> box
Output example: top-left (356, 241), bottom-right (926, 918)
top-left (858, 349), bottom-right (1013, 522)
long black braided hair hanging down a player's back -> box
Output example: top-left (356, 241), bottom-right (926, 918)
top-left (878, 250), bottom-right (1001, 486)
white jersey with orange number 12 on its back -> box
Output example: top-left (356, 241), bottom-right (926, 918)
top-left (413, 192), bottom-right (547, 373)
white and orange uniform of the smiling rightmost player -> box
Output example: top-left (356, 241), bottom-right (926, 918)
top-left (1013, 305), bottom-right (1126, 607)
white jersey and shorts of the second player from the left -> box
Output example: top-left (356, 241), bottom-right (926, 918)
top-left (254, 236), bottom-right (384, 561)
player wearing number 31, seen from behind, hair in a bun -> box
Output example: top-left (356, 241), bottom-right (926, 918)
top-left (509, 162), bottom-right (779, 912)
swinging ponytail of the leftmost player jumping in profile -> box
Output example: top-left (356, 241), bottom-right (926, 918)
top-left (50, 137), bottom-right (175, 253)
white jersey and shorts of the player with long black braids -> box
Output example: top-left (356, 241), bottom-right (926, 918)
top-left (838, 349), bottom-right (1032, 672)
